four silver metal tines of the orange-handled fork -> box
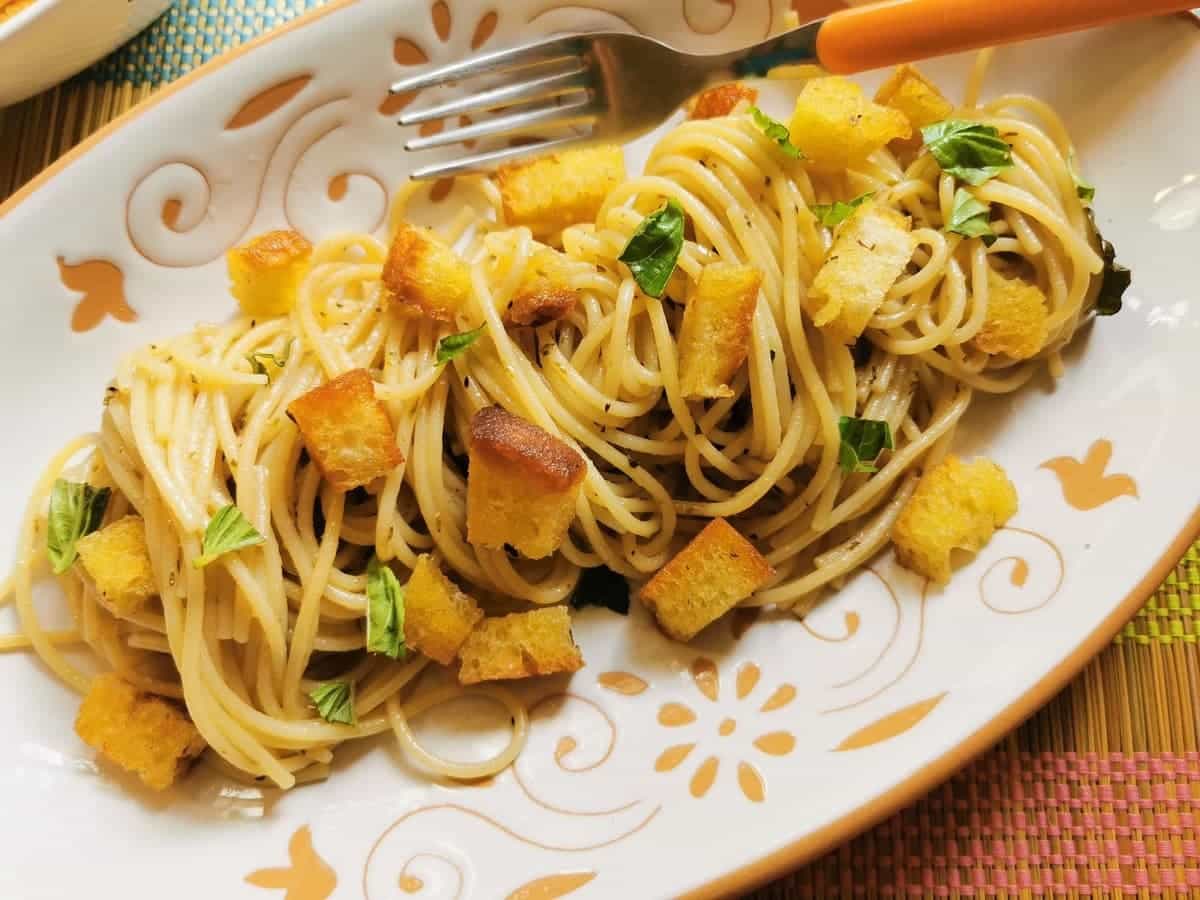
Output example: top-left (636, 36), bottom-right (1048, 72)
top-left (391, 36), bottom-right (600, 179)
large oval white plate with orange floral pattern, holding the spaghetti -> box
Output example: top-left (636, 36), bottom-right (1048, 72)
top-left (0, 0), bottom-right (1200, 900)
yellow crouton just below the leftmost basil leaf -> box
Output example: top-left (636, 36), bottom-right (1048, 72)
top-left (76, 516), bottom-right (158, 616)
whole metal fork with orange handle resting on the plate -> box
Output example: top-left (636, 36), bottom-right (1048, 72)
top-left (391, 0), bottom-right (1195, 179)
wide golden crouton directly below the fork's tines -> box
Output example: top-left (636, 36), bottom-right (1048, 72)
top-left (496, 144), bottom-right (625, 235)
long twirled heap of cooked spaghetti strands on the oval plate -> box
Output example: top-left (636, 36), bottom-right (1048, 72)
top-left (0, 65), bottom-right (1103, 787)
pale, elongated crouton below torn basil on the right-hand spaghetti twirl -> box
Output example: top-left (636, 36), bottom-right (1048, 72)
top-left (805, 200), bottom-right (917, 343)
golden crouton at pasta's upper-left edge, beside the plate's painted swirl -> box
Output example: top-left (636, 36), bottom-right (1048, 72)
top-left (226, 232), bottom-right (312, 317)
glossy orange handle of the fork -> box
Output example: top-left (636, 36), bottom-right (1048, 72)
top-left (817, 0), bottom-right (1198, 74)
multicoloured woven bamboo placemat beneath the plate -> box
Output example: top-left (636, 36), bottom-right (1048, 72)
top-left (0, 0), bottom-right (1200, 900)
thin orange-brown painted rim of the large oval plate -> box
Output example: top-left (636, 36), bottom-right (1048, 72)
top-left (0, 0), bottom-right (1200, 900)
